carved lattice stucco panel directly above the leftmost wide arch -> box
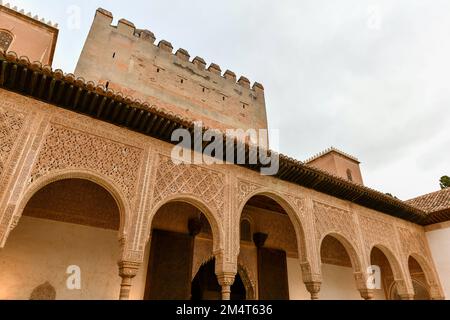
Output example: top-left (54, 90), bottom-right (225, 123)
top-left (30, 124), bottom-right (143, 202)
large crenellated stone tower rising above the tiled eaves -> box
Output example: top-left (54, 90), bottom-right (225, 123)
top-left (75, 8), bottom-right (267, 135)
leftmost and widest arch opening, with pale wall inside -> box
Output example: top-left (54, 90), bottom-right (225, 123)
top-left (0, 178), bottom-right (121, 300)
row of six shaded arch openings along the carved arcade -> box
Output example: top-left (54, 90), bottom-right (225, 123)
top-left (0, 175), bottom-right (442, 300)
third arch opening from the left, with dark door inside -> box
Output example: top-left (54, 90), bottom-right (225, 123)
top-left (240, 194), bottom-right (298, 300)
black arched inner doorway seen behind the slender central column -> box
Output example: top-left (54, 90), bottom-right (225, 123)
top-left (191, 259), bottom-right (246, 301)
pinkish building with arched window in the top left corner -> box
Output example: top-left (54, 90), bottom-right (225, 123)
top-left (0, 1), bottom-right (58, 65)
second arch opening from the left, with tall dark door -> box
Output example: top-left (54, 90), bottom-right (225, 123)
top-left (144, 201), bottom-right (213, 300)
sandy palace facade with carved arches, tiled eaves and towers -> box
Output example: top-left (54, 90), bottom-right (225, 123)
top-left (0, 5), bottom-right (450, 300)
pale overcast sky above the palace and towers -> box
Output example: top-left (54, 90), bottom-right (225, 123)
top-left (4, 0), bottom-right (450, 199)
